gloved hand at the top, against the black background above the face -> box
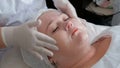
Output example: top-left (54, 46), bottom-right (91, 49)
top-left (53, 0), bottom-right (77, 18)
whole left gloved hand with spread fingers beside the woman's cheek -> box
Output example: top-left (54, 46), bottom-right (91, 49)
top-left (2, 19), bottom-right (58, 59)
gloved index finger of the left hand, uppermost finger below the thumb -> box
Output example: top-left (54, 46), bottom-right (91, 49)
top-left (35, 31), bottom-right (56, 44)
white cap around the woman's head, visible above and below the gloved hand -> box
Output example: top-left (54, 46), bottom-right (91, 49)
top-left (20, 9), bottom-right (56, 68)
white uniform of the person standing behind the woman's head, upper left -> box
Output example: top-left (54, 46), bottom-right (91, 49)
top-left (0, 0), bottom-right (47, 63)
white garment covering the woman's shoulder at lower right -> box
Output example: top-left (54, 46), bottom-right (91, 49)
top-left (92, 26), bottom-right (120, 68)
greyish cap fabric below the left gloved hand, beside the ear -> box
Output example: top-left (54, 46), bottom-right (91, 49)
top-left (21, 49), bottom-right (54, 68)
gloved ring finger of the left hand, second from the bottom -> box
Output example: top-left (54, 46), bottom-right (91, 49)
top-left (34, 46), bottom-right (53, 56)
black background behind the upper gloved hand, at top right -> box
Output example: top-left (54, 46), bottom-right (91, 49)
top-left (46, 0), bottom-right (113, 26)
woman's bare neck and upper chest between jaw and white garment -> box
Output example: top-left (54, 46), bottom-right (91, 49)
top-left (72, 36), bottom-right (111, 68)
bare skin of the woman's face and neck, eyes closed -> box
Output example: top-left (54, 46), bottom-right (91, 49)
top-left (38, 10), bottom-right (110, 68)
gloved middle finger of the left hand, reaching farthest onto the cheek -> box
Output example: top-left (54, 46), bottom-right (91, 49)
top-left (36, 40), bottom-right (59, 50)
